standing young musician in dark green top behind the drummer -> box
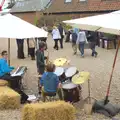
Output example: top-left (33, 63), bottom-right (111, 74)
top-left (36, 42), bottom-right (46, 75)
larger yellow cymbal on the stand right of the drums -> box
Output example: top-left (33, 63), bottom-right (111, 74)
top-left (72, 72), bottom-right (90, 84)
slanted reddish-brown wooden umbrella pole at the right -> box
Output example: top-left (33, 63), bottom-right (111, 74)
top-left (104, 40), bottom-right (120, 104)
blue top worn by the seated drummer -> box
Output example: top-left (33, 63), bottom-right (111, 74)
top-left (40, 72), bottom-right (59, 92)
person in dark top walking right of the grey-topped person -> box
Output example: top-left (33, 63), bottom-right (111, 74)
top-left (87, 31), bottom-right (98, 57)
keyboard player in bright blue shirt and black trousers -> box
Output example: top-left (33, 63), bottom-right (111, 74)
top-left (0, 51), bottom-right (28, 103)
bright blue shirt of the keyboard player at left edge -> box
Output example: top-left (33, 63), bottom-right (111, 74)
top-left (0, 58), bottom-right (14, 77)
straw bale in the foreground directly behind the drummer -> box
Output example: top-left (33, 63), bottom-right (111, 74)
top-left (22, 101), bottom-right (75, 120)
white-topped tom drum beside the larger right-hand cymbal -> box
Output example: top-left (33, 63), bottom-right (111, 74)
top-left (65, 67), bottom-right (77, 78)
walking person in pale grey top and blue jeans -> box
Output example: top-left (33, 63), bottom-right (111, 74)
top-left (76, 30), bottom-right (87, 57)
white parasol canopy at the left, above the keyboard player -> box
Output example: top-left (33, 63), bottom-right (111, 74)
top-left (0, 14), bottom-right (48, 39)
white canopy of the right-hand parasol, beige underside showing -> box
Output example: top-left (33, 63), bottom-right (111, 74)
top-left (63, 11), bottom-right (120, 35)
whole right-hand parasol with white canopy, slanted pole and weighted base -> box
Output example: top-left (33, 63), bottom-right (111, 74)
top-left (63, 11), bottom-right (120, 117)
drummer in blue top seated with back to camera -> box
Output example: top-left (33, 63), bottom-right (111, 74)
top-left (40, 63), bottom-right (62, 101)
